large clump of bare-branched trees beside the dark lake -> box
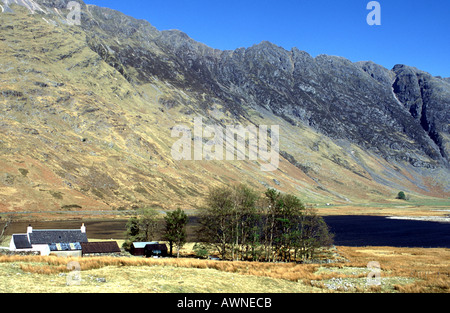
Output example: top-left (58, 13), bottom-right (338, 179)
top-left (198, 185), bottom-right (333, 262)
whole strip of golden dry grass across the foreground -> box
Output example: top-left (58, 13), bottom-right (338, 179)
top-left (0, 247), bottom-right (450, 293)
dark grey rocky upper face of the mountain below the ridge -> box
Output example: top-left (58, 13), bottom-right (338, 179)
top-left (79, 4), bottom-right (450, 167)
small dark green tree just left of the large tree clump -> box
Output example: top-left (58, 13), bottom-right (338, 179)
top-left (164, 208), bottom-right (188, 258)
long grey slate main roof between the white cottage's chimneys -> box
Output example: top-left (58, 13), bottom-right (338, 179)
top-left (29, 229), bottom-right (88, 245)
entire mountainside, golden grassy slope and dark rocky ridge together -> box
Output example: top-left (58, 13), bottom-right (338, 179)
top-left (0, 0), bottom-right (450, 210)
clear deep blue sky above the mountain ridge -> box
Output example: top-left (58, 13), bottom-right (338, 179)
top-left (85, 0), bottom-right (450, 77)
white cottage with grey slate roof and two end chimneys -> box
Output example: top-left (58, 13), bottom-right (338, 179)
top-left (9, 224), bottom-right (88, 256)
